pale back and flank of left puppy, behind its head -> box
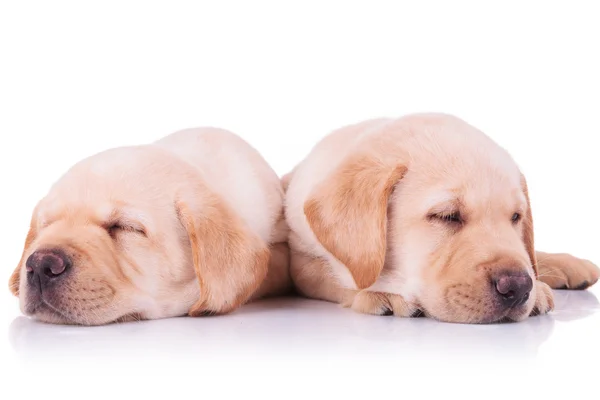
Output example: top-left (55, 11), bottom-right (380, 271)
top-left (155, 128), bottom-right (291, 299)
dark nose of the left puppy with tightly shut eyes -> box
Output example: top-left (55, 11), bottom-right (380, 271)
top-left (25, 249), bottom-right (71, 287)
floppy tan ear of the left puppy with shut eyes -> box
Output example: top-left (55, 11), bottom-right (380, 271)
top-left (175, 184), bottom-right (270, 316)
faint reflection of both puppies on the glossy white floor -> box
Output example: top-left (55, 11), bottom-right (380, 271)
top-left (9, 291), bottom-right (599, 361)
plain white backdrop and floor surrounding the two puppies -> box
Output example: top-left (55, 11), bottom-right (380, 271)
top-left (0, 1), bottom-right (600, 399)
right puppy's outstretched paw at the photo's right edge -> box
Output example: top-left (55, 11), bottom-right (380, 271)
top-left (538, 253), bottom-right (600, 290)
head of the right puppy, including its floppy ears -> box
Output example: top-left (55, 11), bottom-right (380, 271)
top-left (305, 115), bottom-right (536, 323)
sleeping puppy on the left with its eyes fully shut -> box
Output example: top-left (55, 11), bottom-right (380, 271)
top-left (9, 128), bottom-right (291, 325)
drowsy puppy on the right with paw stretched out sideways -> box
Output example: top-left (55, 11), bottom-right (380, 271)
top-left (283, 114), bottom-right (600, 323)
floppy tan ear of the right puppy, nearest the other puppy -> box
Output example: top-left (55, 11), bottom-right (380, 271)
top-left (304, 153), bottom-right (406, 289)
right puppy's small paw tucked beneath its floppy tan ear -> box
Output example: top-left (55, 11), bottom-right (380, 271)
top-left (350, 290), bottom-right (418, 317)
